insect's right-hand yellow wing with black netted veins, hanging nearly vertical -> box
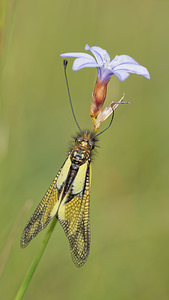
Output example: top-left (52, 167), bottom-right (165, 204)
top-left (58, 161), bottom-right (91, 267)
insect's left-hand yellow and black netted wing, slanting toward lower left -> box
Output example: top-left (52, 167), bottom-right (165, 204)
top-left (20, 155), bottom-right (71, 248)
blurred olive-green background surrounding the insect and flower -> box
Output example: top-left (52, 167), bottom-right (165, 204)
top-left (0, 0), bottom-right (169, 300)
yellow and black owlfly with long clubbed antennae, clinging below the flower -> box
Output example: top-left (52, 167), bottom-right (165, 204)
top-left (20, 62), bottom-right (114, 267)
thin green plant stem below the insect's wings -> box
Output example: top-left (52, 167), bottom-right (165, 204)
top-left (15, 218), bottom-right (57, 300)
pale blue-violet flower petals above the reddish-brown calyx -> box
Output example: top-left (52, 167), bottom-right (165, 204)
top-left (60, 45), bottom-right (150, 82)
